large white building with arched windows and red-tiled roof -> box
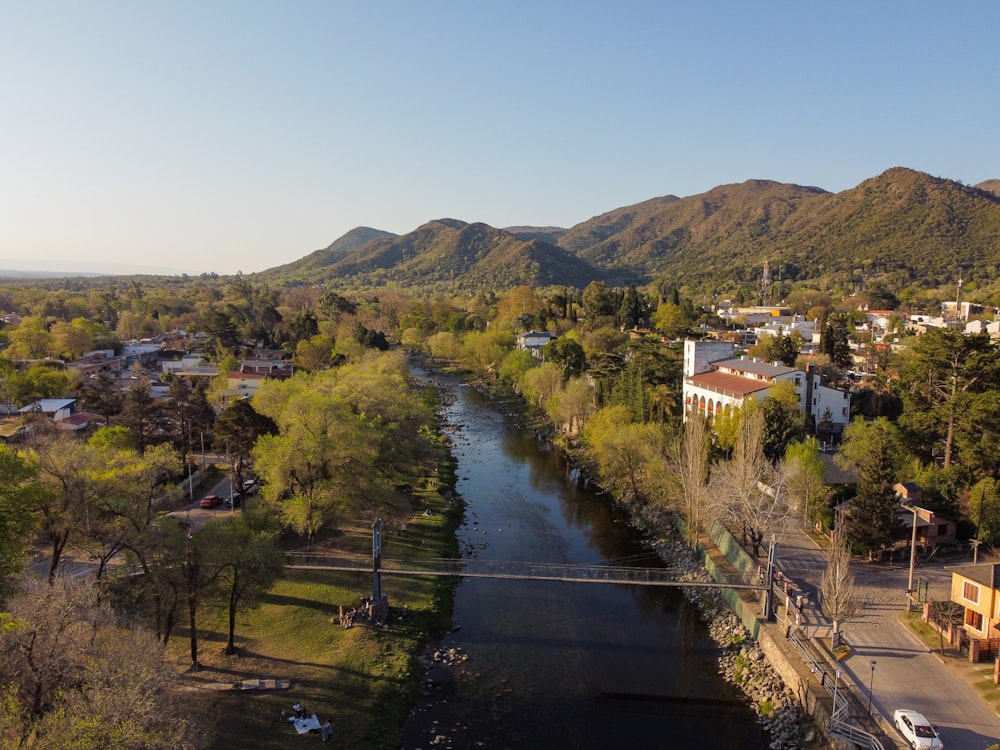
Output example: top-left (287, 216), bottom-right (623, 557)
top-left (683, 340), bottom-right (851, 434)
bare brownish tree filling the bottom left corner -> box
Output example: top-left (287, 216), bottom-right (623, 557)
top-left (0, 578), bottom-right (210, 750)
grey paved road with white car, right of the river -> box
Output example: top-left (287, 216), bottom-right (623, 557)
top-left (777, 527), bottom-right (1000, 750)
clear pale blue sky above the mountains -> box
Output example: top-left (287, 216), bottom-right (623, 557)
top-left (0, 0), bottom-right (1000, 274)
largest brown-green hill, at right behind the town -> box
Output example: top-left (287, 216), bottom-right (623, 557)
top-left (560, 168), bottom-right (1000, 287)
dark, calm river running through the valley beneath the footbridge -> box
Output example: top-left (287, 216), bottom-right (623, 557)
top-left (402, 380), bottom-right (765, 750)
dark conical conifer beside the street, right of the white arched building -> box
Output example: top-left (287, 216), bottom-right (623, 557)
top-left (840, 418), bottom-right (903, 557)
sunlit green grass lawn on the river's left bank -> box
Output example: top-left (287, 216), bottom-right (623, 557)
top-left (170, 476), bottom-right (461, 750)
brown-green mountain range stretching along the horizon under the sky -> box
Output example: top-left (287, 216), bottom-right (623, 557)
top-left (256, 167), bottom-right (1000, 292)
